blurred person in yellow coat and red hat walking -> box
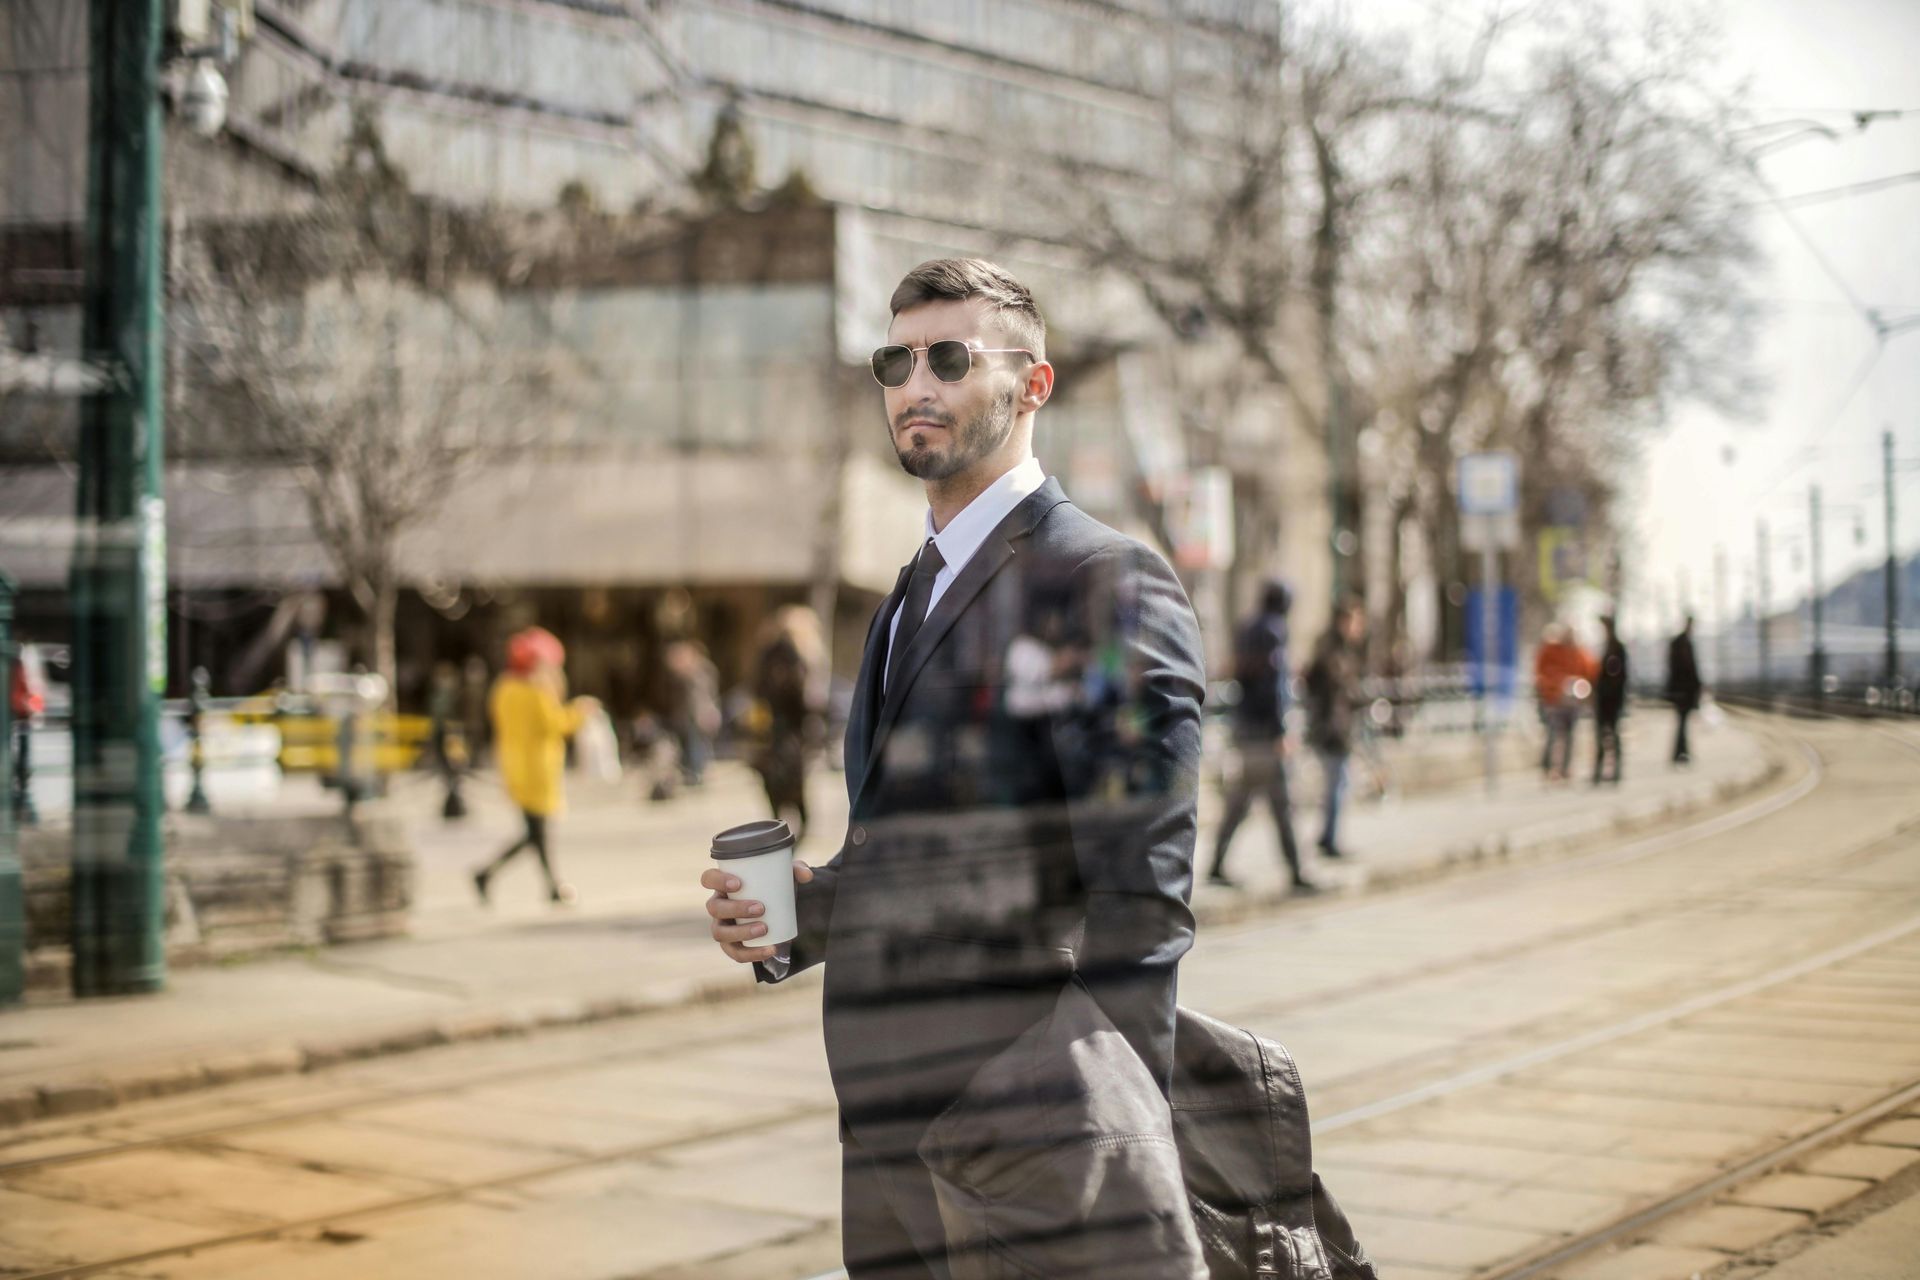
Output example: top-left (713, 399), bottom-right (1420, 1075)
top-left (474, 628), bottom-right (597, 902)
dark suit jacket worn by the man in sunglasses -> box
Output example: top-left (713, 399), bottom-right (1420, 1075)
top-left (756, 480), bottom-right (1206, 1153)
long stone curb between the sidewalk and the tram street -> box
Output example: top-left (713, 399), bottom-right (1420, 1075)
top-left (0, 736), bottom-right (1786, 1130)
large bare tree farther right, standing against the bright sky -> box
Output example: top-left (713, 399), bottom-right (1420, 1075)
top-left (1359, 5), bottom-right (1755, 652)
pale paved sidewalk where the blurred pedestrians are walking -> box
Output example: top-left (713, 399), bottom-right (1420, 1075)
top-left (0, 714), bottom-right (1778, 1126)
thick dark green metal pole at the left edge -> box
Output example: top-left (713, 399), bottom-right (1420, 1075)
top-left (73, 0), bottom-right (167, 996)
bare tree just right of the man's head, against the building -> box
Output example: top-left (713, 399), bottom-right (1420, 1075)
top-left (1050, 0), bottom-right (1509, 625)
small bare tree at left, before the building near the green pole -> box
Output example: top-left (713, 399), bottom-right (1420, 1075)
top-left (171, 117), bottom-right (540, 691)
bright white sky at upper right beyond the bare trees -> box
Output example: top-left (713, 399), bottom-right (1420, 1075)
top-left (1323, 0), bottom-right (1920, 631)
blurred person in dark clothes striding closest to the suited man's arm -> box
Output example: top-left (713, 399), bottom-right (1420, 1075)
top-left (1208, 580), bottom-right (1317, 892)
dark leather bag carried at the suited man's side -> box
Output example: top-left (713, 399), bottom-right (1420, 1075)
top-left (920, 981), bottom-right (1377, 1280)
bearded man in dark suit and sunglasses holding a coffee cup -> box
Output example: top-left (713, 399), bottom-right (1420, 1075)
top-left (701, 259), bottom-right (1206, 1280)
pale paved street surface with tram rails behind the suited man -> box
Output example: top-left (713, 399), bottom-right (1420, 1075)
top-left (0, 722), bottom-right (1920, 1280)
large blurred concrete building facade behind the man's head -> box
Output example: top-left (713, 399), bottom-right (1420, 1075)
top-left (0, 0), bottom-right (1327, 710)
